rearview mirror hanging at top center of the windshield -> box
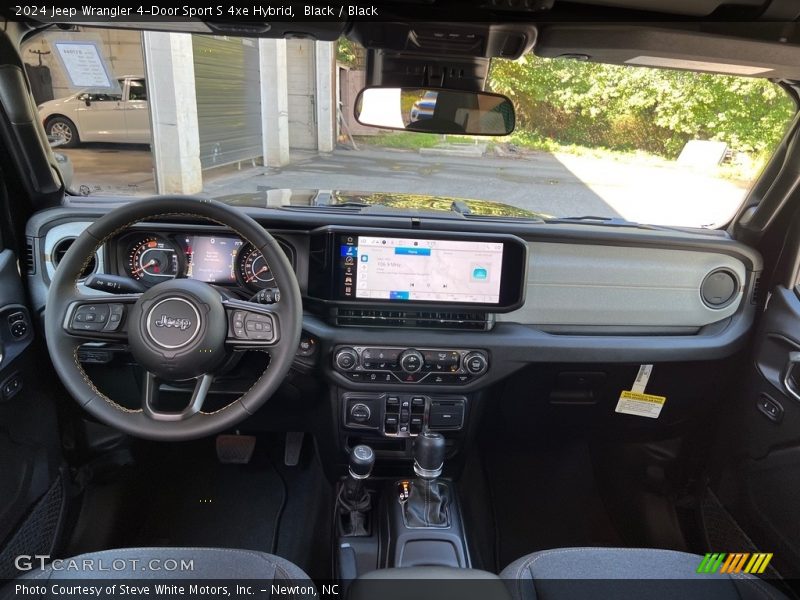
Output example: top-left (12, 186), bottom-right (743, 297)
top-left (355, 87), bottom-right (516, 135)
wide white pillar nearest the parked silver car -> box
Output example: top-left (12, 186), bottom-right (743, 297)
top-left (143, 31), bottom-right (203, 194)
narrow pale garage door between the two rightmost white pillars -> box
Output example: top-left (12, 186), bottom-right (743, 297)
top-left (286, 40), bottom-right (317, 150)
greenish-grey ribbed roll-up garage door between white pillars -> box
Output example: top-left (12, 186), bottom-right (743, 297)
top-left (192, 35), bottom-right (263, 169)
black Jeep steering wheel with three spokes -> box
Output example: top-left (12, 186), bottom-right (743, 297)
top-left (45, 196), bottom-right (303, 440)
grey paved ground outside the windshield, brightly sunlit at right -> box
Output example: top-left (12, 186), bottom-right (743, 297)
top-left (59, 144), bottom-right (746, 227)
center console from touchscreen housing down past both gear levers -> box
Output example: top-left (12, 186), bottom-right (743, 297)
top-left (308, 227), bottom-right (528, 581)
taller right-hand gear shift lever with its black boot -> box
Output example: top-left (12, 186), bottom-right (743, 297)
top-left (403, 430), bottom-right (450, 527)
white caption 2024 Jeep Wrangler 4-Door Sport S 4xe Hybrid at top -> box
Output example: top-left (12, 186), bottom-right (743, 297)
top-left (12, 3), bottom-right (380, 21)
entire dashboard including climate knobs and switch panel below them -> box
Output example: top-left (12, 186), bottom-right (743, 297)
top-left (26, 200), bottom-right (761, 444)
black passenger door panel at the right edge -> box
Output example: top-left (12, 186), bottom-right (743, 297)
top-left (711, 287), bottom-right (800, 578)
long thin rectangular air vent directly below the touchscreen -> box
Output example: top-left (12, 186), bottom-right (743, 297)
top-left (334, 308), bottom-right (491, 331)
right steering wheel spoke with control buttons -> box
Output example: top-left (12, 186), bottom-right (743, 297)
top-left (222, 300), bottom-right (281, 350)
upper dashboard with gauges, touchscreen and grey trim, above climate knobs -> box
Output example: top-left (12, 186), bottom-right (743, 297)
top-left (26, 206), bottom-right (761, 368)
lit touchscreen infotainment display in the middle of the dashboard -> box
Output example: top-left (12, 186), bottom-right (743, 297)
top-left (339, 236), bottom-right (504, 304)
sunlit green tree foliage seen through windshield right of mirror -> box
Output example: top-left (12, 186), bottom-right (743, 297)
top-left (489, 54), bottom-right (795, 158)
